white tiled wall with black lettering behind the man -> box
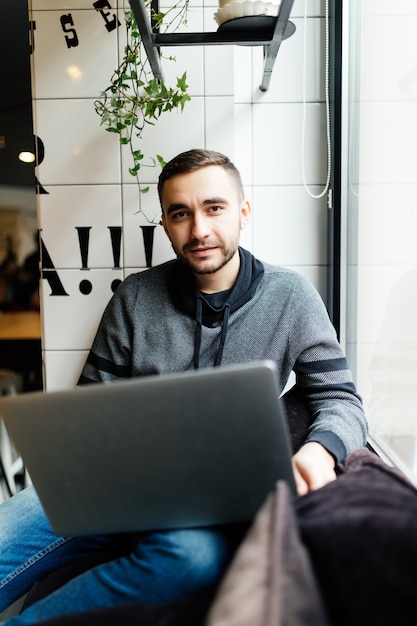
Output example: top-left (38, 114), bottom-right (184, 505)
top-left (32, 0), bottom-right (327, 389)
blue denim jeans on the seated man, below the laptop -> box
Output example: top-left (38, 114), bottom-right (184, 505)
top-left (0, 487), bottom-right (241, 626)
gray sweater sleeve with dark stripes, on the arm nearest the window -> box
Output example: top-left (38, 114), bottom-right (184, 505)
top-left (290, 277), bottom-right (368, 462)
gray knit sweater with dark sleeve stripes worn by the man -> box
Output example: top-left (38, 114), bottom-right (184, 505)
top-left (79, 254), bottom-right (367, 462)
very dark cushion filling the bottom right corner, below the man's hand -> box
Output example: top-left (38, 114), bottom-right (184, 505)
top-left (294, 448), bottom-right (417, 626)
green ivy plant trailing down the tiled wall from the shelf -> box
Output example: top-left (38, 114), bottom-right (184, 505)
top-left (94, 0), bottom-right (191, 224)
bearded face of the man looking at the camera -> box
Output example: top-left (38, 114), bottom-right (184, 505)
top-left (162, 165), bottom-right (250, 275)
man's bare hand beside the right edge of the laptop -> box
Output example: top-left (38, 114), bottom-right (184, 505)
top-left (292, 441), bottom-right (336, 496)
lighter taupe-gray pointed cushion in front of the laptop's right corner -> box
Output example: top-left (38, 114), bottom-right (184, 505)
top-left (205, 481), bottom-right (328, 626)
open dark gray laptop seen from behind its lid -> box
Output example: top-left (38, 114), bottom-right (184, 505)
top-left (0, 361), bottom-right (295, 535)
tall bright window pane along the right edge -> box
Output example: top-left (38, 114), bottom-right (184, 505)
top-left (342, 0), bottom-right (417, 482)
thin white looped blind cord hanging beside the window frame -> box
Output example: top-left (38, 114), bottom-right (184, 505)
top-left (301, 0), bottom-right (332, 198)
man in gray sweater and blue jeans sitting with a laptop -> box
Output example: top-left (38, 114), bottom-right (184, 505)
top-left (0, 150), bottom-right (367, 624)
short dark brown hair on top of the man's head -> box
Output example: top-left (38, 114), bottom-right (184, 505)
top-left (158, 148), bottom-right (245, 206)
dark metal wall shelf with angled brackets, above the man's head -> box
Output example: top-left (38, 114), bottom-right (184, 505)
top-left (129, 0), bottom-right (295, 91)
